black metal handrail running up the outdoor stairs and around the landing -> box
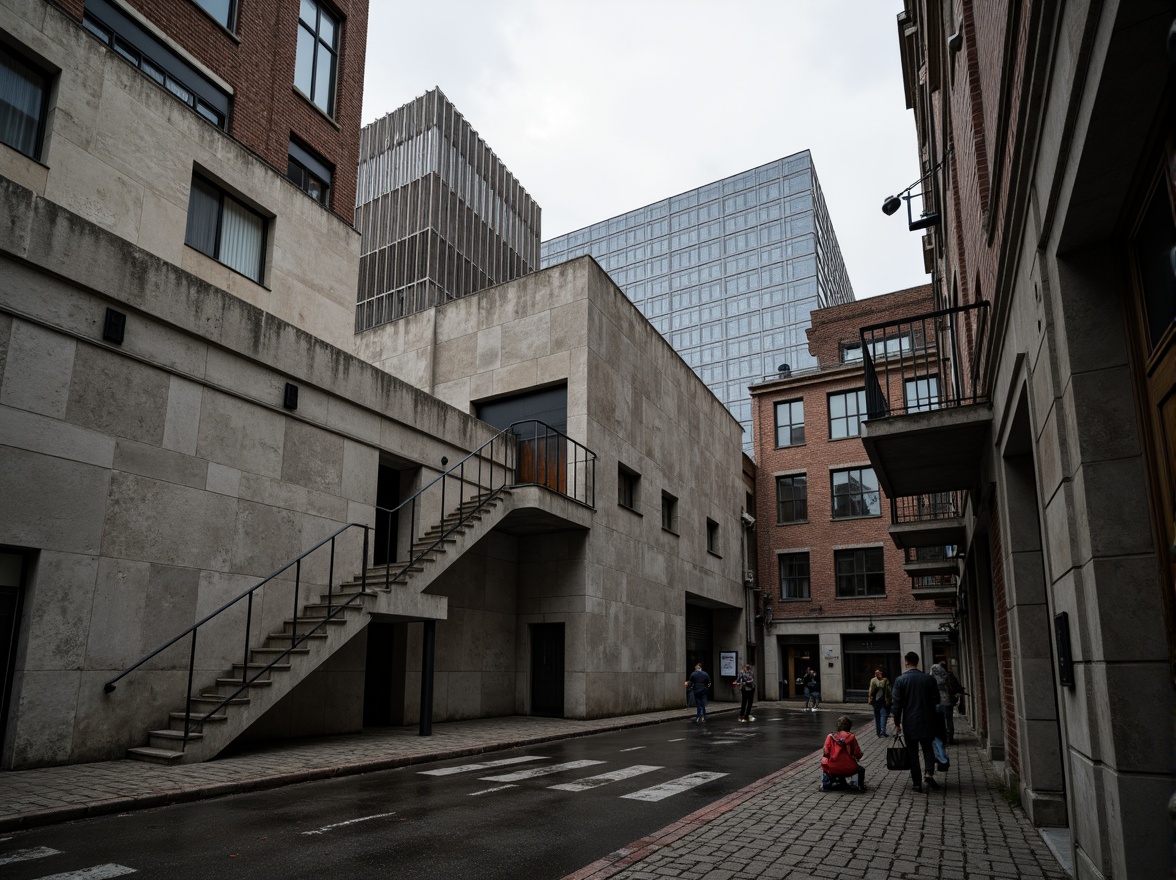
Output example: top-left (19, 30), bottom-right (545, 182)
top-left (102, 420), bottom-right (596, 748)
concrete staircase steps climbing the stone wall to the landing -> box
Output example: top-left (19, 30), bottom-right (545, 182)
top-left (127, 488), bottom-right (513, 764)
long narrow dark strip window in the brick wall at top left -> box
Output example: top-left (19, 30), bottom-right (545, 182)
top-left (82, 0), bottom-right (232, 131)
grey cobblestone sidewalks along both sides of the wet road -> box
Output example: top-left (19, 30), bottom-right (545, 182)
top-left (0, 704), bottom-right (1067, 880)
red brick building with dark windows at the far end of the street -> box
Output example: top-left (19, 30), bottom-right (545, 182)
top-left (750, 285), bottom-right (961, 702)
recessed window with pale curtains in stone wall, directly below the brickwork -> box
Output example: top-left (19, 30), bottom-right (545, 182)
top-left (183, 176), bottom-right (266, 284)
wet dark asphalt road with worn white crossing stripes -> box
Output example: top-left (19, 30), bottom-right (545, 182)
top-left (0, 709), bottom-right (868, 880)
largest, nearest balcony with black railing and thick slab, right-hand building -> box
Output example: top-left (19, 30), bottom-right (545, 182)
top-left (861, 302), bottom-right (993, 498)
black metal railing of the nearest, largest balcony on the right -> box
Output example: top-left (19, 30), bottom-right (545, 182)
top-left (861, 302), bottom-right (988, 419)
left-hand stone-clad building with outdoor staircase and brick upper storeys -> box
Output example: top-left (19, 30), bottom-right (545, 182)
top-left (0, 0), bottom-right (746, 768)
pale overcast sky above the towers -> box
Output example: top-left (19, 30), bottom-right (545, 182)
top-left (363, 0), bottom-right (928, 299)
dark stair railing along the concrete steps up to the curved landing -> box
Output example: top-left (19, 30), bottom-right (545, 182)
top-left (102, 420), bottom-right (596, 749)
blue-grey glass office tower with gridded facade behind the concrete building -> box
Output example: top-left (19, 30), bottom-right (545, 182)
top-left (541, 151), bottom-right (854, 454)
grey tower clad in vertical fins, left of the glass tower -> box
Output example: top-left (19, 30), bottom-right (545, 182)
top-left (355, 88), bottom-right (541, 332)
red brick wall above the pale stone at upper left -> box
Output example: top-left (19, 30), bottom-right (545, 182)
top-left (58, 0), bottom-right (368, 224)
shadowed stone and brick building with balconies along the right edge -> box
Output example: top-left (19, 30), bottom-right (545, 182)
top-left (862, 0), bottom-right (1176, 879)
